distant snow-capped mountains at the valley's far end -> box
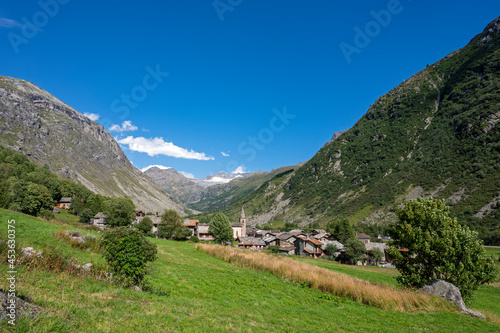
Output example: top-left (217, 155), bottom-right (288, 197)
top-left (144, 166), bottom-right (297, 211)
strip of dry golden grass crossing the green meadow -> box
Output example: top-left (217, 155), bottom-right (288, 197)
top-left (196, 244), bottom-right (456, 312)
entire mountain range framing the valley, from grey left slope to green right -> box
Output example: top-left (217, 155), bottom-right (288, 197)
top-left (0, 18), bottom-right (500, 244)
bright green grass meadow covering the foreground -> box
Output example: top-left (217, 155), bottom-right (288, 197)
top-left (0, 210), bottom-right (500, 332)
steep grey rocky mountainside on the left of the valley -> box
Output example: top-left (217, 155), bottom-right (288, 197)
top-left (0, 76), bottom-right (184, 212)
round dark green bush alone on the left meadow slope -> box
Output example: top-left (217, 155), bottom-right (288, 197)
top-left (101, 227), bottom-right (157, 285)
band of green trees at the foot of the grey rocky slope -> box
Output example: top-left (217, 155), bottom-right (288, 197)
top-left (0, 146), bottom-right (135, 226)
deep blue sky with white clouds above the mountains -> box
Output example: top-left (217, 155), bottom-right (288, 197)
top-left (0, 0), bottom-right (500, 178)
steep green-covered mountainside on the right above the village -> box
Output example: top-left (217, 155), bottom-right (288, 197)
top-left (227, 19), bottom-right (500, 241)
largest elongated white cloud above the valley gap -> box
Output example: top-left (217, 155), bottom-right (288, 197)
top-left (117, 136), bottom-right (214, 161)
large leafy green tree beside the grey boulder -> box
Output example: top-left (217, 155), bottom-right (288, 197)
top-left (389, 198), bottom-right (497, 300)
